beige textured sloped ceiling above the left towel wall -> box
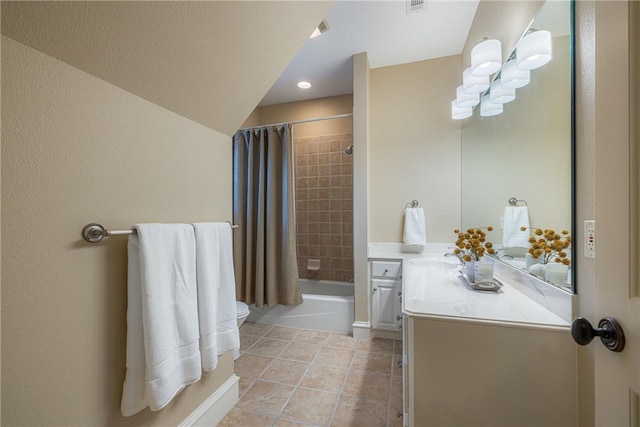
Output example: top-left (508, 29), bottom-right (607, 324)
top-left (2, 1), bottom-right (333, 135)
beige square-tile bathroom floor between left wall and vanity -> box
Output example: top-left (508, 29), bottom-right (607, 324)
top-left (219, 323), bottom-right (402, 427)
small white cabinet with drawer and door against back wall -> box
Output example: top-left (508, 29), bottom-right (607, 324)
top-left (371, 260), bottom-right (402, 331)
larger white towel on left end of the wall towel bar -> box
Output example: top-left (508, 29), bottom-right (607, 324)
top-left (121, 224), bottom-right (202, 416)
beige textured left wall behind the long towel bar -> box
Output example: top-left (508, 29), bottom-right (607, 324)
top-left (2, 36), bottom-right (233, 426)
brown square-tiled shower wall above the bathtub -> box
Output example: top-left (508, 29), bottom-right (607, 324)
top-left (294, 133), bottom-right (353, 281)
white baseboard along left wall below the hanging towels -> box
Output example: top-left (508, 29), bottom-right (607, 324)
top-left (180, 374), bottom-right (240, 427)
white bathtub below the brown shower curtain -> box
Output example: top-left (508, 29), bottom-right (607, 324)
top-left (247, 279), bottom-right (354, 334)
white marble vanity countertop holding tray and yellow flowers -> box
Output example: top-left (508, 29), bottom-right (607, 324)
top-left (369, 243), bottom-right (569, 328)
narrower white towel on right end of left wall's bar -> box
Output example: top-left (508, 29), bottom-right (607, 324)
top-left (193, 222), bottom-right (240, 371)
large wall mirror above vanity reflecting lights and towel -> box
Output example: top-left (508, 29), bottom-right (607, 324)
top-left (462, 0), bottom-right (576, 293)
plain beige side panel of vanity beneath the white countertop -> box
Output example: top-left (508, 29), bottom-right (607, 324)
top-left (403, 316), bottom-right (577, 427)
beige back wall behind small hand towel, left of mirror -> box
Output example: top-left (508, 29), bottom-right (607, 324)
top-left (369, 55), bottom-right (462, 242)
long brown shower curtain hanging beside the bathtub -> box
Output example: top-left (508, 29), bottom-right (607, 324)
top-left (233, 125), bottom-right (302, 307)
